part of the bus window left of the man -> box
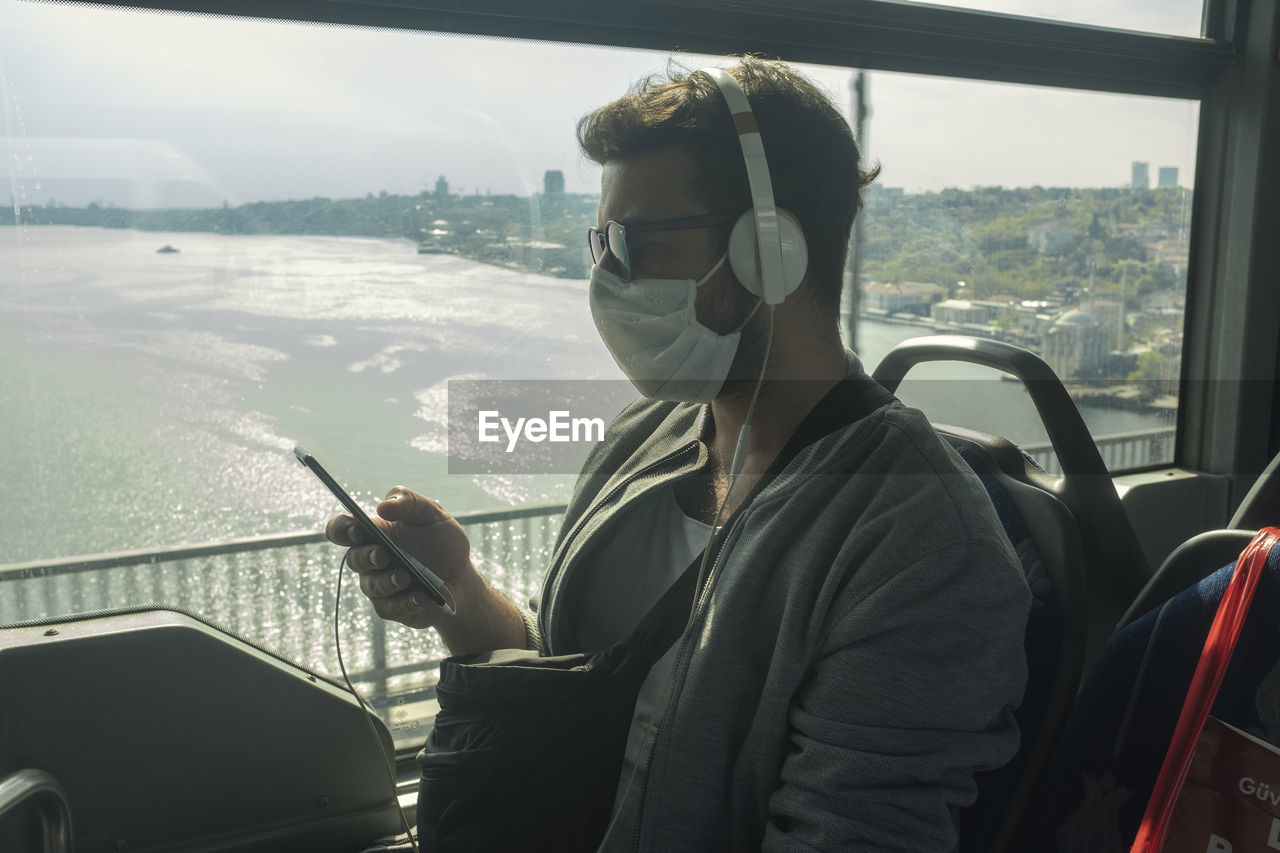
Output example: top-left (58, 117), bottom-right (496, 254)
top-left (0, 1), bottom-right (640, 745)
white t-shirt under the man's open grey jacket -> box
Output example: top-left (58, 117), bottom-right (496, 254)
top-left (579, 487), bottom-right (712, 849)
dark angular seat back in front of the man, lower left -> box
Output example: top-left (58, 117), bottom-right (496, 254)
top-left (0, 607), bottom-right (401, 853)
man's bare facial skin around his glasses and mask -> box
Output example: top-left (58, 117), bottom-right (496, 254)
top-left (596, 149), bottom-right (756, 334)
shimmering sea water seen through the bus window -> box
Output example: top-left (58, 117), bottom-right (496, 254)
top-left (0, 227), bottom-right (1167, 564)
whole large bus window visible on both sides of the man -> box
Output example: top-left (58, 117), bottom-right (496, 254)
top-left (0, 0), bottom-right (1197, 747)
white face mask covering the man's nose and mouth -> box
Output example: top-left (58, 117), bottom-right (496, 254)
top-left (590, 254), bottom-right (760, 402)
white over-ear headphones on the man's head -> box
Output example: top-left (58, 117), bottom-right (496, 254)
top-left (703, 68), bottom-right (809, 305)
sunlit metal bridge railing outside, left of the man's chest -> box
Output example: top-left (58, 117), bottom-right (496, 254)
top-left (0, 505), bottom-right (564, 745)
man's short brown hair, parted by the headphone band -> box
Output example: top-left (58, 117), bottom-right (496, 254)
top-left (577, 56), bottom-right (879, 316)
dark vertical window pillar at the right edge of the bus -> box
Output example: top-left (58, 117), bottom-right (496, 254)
top-left (1176, 0), bottom-right (1280, 484)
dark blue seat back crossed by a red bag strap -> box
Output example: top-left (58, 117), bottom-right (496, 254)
top-left (1016, 537), bottom-right (1280, 853)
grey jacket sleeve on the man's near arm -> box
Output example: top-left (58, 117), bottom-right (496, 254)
top-left (763, 539), bottom-right (1030, 853)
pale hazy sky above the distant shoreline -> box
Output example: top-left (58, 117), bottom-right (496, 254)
top-left (0, 0), bottom-right (1199, 207)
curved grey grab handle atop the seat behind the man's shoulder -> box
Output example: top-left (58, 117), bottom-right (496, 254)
top-left (872, 336), bottom-right (1152, 669)
